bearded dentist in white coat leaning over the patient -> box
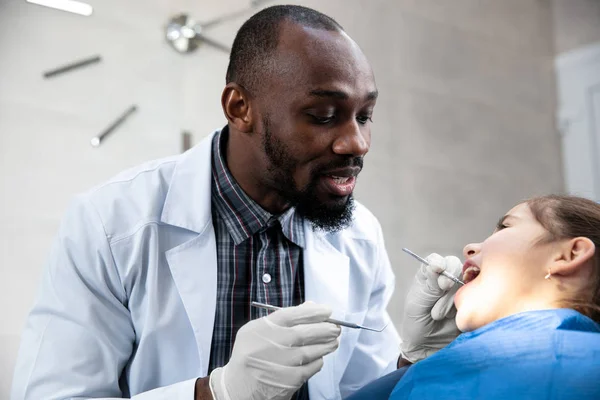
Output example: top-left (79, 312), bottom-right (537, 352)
top-left (12, 6), bottom-right (460, 400)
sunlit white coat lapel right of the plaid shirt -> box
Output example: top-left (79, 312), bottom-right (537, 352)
top-left (304, 227), bottom-right (349, 399)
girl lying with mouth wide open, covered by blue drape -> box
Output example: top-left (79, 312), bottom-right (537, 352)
top-left (351, 196), bottom-right (600, 400)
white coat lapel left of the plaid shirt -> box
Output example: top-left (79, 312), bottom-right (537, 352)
top-left (161, 131), bottom-right (217, 376)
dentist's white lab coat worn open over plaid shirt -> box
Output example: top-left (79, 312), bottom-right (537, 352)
top-left (12, 131), bottom-right (399, 400)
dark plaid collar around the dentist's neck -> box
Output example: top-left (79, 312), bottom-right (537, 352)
top-left (212, 127), bottom-right (305, 247)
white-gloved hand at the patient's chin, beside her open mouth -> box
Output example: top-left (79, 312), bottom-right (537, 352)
top-left (400, 253), bottom-right (463, 363)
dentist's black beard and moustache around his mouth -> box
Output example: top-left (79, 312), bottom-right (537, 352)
top-left (263, 118), bottom-right (363, 232)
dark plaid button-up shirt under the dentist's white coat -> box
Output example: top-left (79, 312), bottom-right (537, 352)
top-left (208, 128), bottom-right (305, 373)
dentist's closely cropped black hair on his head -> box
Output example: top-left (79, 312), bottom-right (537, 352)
top-left (225, 5), bottom-right (344, 92)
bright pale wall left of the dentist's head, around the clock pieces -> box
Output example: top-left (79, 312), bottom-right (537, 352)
top-left (0, 0), bottom-right (231, 390)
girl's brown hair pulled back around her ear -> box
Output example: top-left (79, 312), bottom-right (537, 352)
top-left (525, 195), bottom-right (600, 322)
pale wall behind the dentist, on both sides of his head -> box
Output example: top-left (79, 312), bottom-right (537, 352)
top-left (0, 0), bottom-right (563, 398)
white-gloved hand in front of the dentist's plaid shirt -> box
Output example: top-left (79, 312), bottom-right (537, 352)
top-left (210, 303), bottom-right (341, 400)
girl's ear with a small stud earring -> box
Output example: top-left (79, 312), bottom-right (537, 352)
top-left (551, 237), bottom-right (596, 275)
